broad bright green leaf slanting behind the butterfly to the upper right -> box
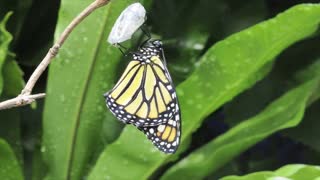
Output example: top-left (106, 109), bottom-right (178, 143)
top-left (89, 4), bottom-right (320, 180)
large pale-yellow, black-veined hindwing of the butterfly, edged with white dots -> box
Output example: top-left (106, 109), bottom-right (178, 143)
top-left (105, 56), bottom-right (177, 126)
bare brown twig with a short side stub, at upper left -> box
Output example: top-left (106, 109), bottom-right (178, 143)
top-left (0, 0), bottom-right (110, 110)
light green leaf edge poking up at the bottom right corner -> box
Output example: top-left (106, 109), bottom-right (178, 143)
top-left (221, 164), bottom-right (320, 180)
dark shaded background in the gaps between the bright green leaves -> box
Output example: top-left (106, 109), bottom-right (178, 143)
top-left (0, 0), bottom-right (320, 179)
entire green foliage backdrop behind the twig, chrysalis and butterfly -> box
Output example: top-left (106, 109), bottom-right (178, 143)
top-left (0, 0), bottom-right (320, 180)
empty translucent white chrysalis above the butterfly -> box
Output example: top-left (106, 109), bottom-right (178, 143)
top-left (108, 3), bottom-right (146, 45)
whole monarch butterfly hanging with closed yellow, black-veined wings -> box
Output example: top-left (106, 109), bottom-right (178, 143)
top-left (104, 40), bottom-right (181, 153)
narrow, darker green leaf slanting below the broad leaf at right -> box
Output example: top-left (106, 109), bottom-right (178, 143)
top-left (162, 60), bottom-right (320, 179)
